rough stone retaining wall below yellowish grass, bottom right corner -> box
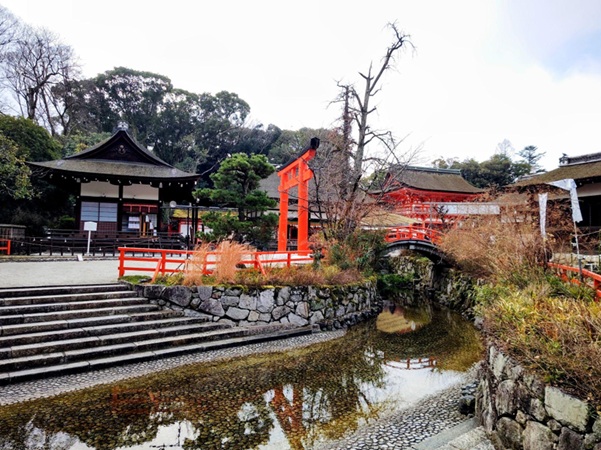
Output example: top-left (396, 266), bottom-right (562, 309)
top-left (476, 345), bottom-right (601, 450)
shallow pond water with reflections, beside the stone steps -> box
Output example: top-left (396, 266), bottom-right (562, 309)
top-left (0, 304), bottom-right (482, 450)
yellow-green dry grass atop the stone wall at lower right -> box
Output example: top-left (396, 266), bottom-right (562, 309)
top-left (483, 286), bottom-right (601, 408)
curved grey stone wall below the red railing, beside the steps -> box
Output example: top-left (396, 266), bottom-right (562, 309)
top-left (136, 281), bottom-right (381, 330)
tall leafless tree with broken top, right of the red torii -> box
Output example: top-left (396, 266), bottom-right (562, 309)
top-left (312, 23), bottom-right (418, 243)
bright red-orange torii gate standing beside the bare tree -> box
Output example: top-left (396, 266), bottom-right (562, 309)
top-left (278, 138), bottom-right (319, 252)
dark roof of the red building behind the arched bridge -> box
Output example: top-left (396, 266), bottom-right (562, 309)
top-left (388, 166), bottom-right (484, 194)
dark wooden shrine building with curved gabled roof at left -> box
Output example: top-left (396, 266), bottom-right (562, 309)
top-left (29, 124), bottom-right (200, 236)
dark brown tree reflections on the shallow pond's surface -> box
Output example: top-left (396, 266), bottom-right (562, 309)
top-left (0, 306), bottom-right (480, 450)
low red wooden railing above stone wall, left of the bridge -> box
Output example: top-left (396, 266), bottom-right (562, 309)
top-left (119, 247), bottom-right (313, 279)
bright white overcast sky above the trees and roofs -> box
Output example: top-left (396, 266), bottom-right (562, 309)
top-left (0, 0), bottom-right (601, 169)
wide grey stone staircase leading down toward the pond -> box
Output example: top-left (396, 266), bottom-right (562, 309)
top-left (0, 284), bottom-right (311, 384)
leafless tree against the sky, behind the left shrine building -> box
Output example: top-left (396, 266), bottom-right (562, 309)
top-left (3, 27), bottom-right (79, 130)
